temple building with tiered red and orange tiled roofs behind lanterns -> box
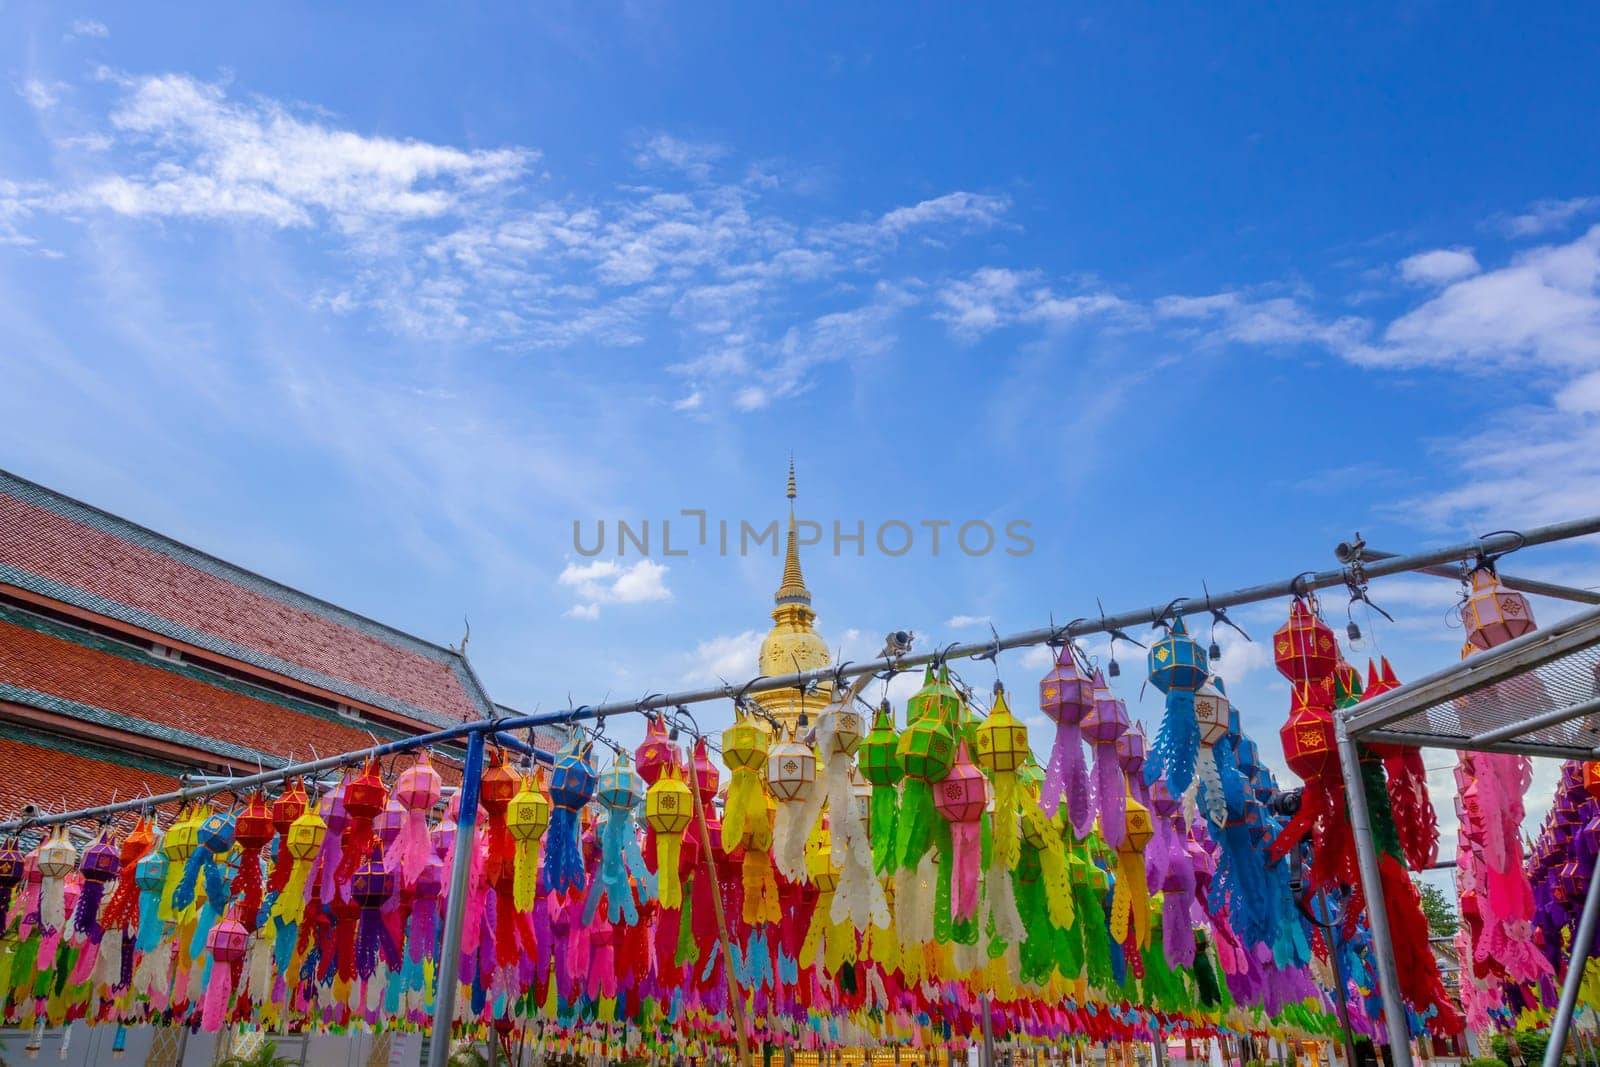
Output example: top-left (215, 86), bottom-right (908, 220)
top-left (0, 472), bottom-right (558, 819)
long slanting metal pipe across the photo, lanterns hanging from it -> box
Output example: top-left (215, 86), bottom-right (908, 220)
top-left (0, 515), bottom-right (1600, 833)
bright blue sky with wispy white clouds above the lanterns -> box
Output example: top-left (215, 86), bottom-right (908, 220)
top-left (0, 3), bottom-right (1600, 831)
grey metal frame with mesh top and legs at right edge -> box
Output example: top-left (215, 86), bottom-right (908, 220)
top-left (1334, 608), bottom-right (1600, 1067)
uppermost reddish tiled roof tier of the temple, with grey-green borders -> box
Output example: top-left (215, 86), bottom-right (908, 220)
top-left (0, 472), bottom-right (493, 726)
